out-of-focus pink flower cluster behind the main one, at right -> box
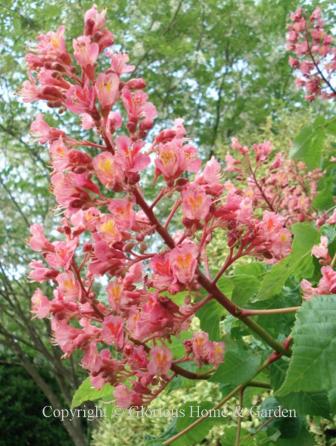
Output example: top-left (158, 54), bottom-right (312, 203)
top-left (224, 138), bottom-right (322, 244)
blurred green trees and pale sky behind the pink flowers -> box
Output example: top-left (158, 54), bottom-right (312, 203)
top-left (0, 0), bottom-right (336, 446)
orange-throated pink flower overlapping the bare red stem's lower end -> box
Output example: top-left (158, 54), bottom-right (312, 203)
top-left (169, 241), bottom-right (198, 284)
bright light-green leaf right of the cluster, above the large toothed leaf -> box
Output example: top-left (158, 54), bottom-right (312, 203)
top-left (258, 223), bottom-right (319, 300)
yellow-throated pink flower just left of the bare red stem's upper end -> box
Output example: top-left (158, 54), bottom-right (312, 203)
top-left (93, 152), bottom-right (123, 189)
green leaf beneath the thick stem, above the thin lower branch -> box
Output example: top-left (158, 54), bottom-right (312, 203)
top-left (209, 342), bottom-right (261, 385)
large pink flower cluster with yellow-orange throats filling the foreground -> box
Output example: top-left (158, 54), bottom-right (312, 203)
top-left (22, 7), bottom-right (317, 407)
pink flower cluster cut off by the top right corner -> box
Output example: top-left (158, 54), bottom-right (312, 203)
top-left (287, 8), bottom-right (336, 101)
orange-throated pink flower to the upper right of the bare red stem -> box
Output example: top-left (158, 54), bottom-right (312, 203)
top-left (182, 183), bottom-right (211, 221)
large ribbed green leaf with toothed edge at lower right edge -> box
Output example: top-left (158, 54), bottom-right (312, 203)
top-left (277, 295), bottom-right (336, 396)
